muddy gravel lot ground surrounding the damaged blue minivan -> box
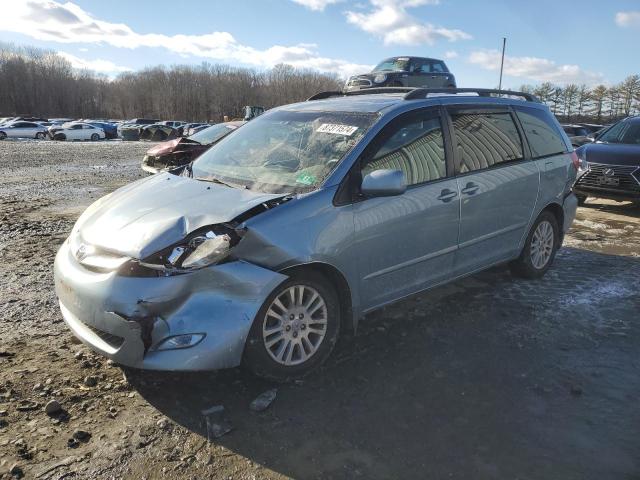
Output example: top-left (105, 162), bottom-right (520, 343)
top-left (0, 141), bottom-right (640, 480)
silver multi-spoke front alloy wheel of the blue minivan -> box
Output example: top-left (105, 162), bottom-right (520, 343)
top-left (262, 285), bottom-right (327, 366)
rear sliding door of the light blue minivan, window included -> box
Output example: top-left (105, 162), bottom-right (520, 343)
top-left (450, 108), bottom-right (540, 274)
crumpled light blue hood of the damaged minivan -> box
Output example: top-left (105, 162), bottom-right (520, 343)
top-left (73, 173), bottom-right (282, 259)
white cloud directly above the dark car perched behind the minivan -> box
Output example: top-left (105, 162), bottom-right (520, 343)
top-left (346, 0), bottom-right (471, 45)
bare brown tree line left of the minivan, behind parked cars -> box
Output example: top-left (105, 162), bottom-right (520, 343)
top-left (0, 44), bottom-right (342, 122)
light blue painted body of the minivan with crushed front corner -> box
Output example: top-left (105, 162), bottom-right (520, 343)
top-left (55, 94), bottom-right (577, 370)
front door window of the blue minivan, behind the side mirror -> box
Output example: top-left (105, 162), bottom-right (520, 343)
top-left (362, 114), bottom-right (447, 185)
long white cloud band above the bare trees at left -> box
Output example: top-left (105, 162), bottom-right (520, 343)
top-left (0, 0), bottom-right (370, 77)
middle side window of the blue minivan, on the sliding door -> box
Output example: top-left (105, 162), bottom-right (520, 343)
top-left (451, 113), bottom-right (524, 173)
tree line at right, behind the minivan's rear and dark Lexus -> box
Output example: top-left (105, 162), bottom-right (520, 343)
top-left (520, 75), bottom-right (640, 124)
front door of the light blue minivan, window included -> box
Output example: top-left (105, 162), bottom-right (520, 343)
top-left (354, 108), bottom-right (460, 311)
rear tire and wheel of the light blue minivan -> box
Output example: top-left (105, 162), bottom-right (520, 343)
top-left (509, 211), bottom-right (560, 278)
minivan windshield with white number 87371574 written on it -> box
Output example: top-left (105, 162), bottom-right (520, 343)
top-left (192, 110), bottom-right (377, 193)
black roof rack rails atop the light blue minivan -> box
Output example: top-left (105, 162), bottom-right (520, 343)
top-left (307, 87), bottom-right (540, 103)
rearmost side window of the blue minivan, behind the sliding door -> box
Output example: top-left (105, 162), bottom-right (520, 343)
top-left (517, 108), bottom-right (567, 158)
